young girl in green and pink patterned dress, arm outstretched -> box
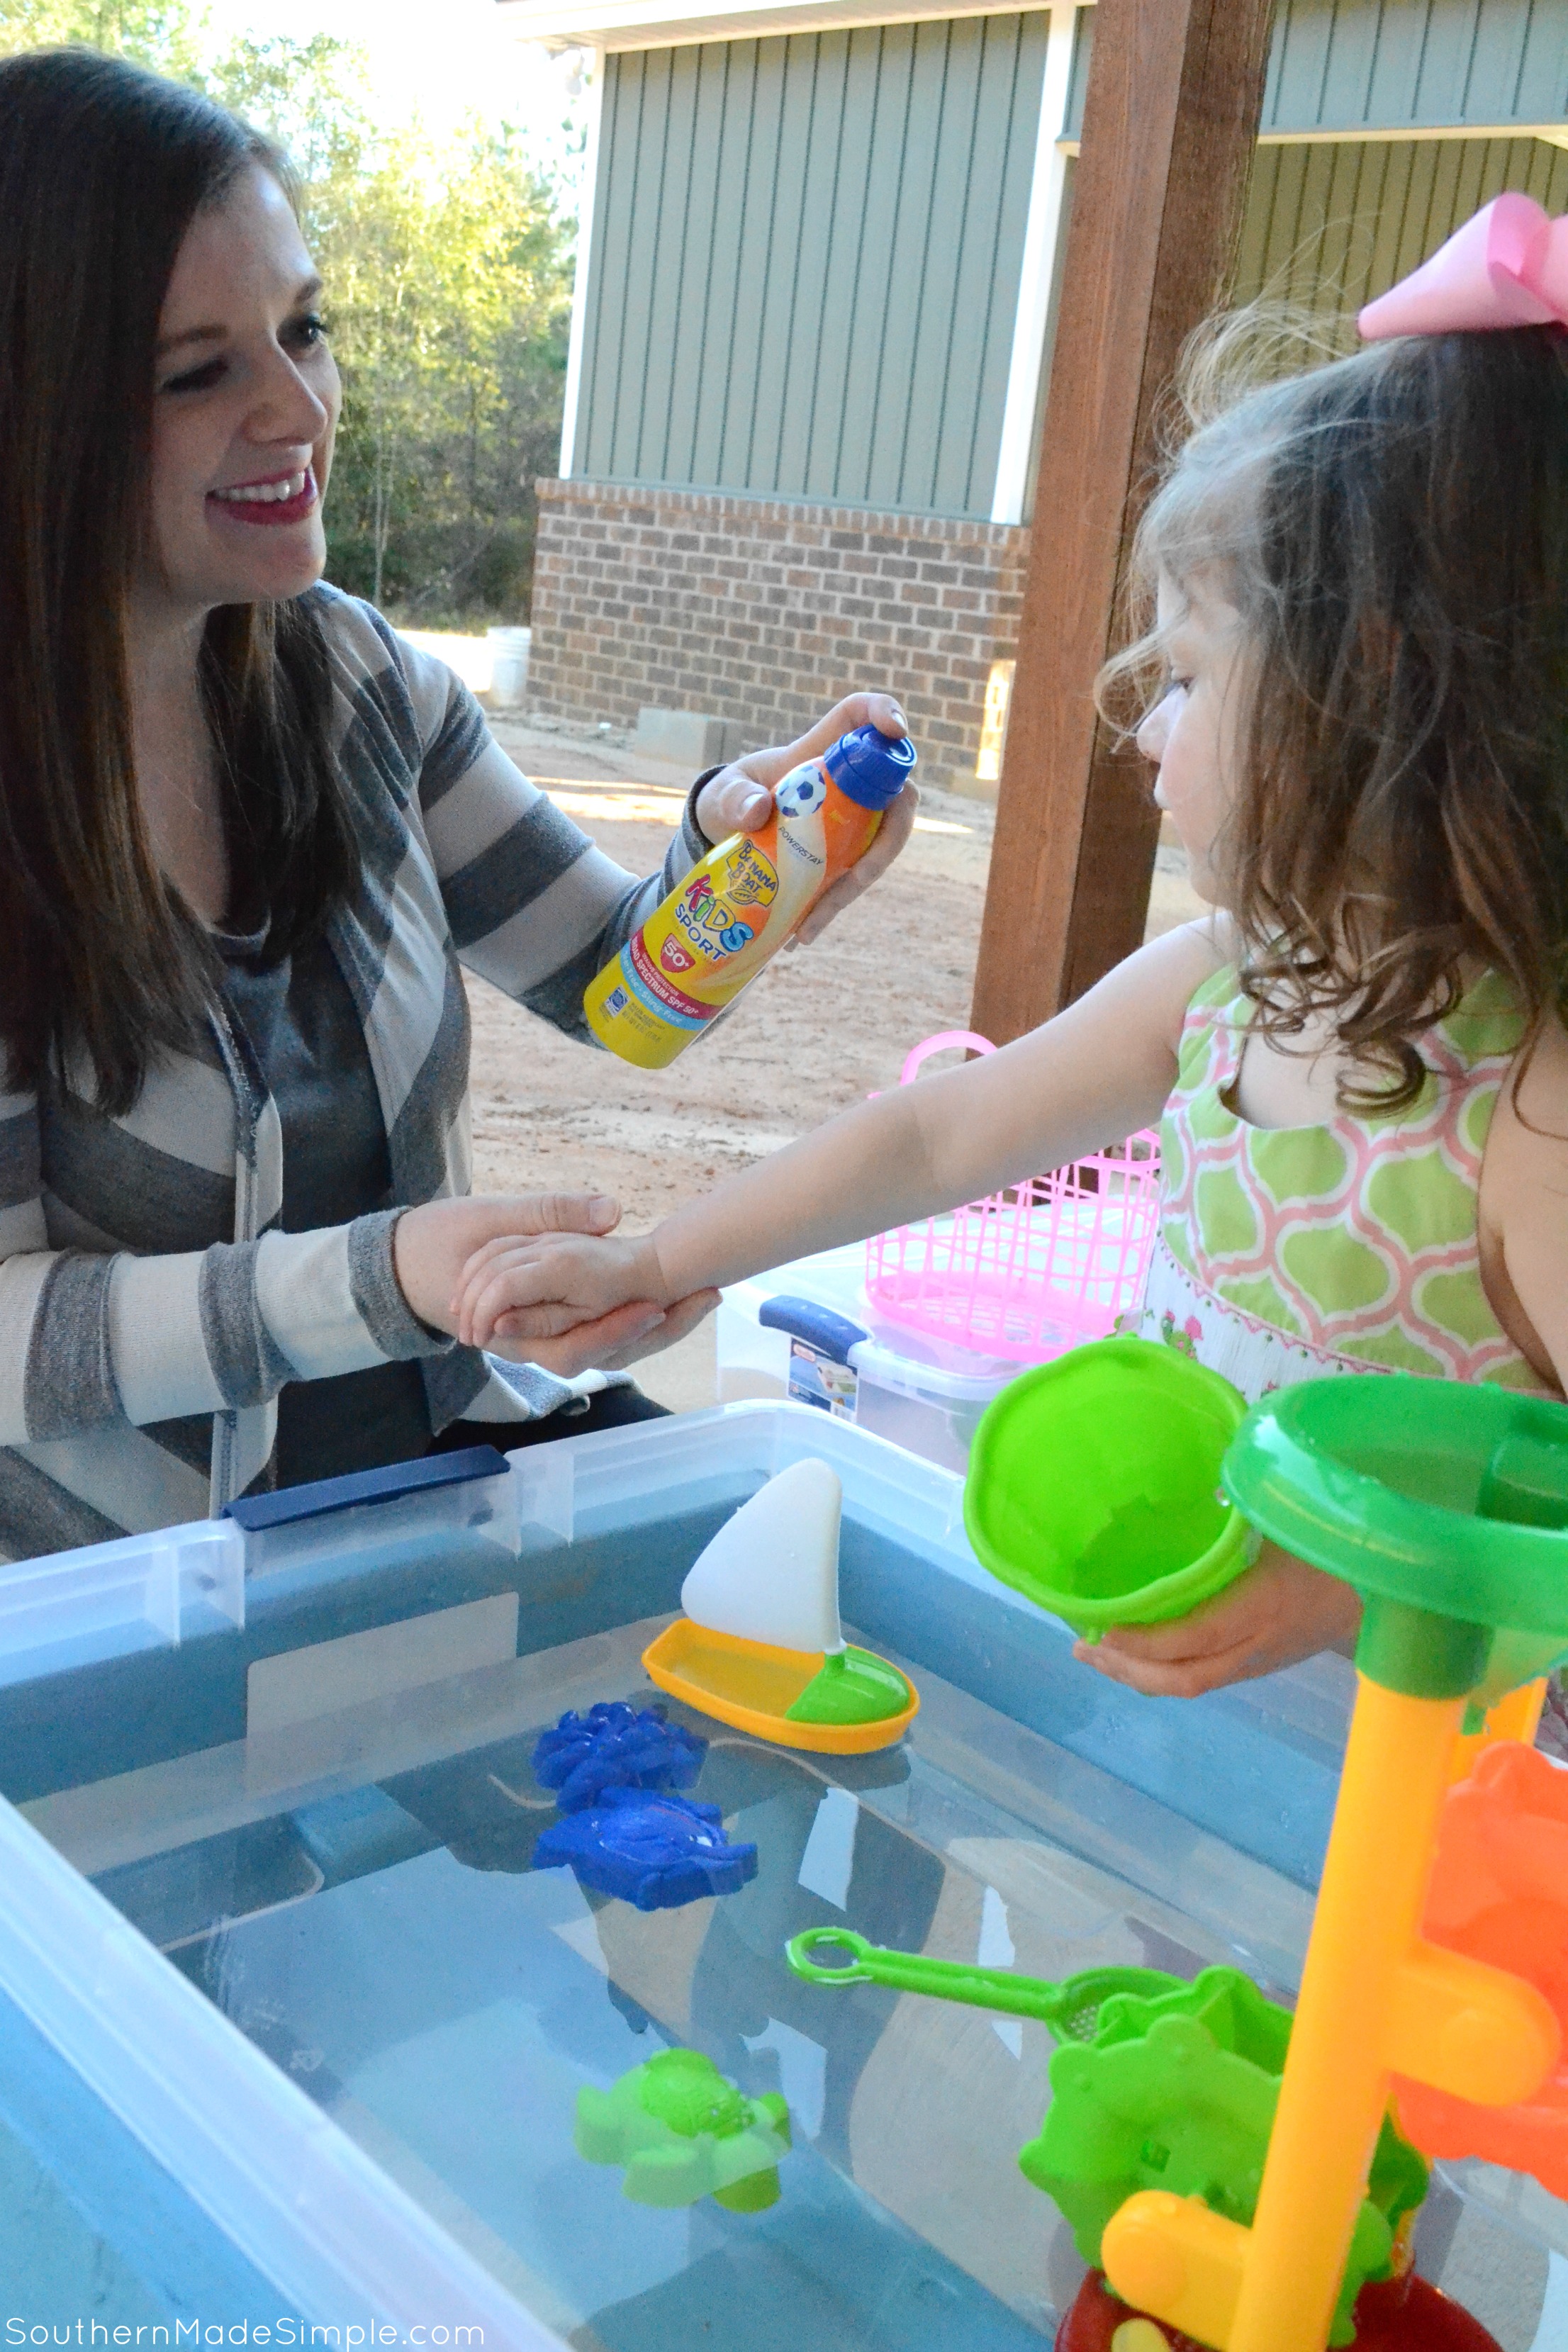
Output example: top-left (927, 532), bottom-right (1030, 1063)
top-left (444, 216), bottom-right (1568, 1693)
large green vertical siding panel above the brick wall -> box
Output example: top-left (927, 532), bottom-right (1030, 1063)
top-left (571, 12), bottom-right (1046, 515)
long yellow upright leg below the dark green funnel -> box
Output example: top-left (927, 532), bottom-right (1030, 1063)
top-left (1227, 1674), bottom-right (1465, 2352)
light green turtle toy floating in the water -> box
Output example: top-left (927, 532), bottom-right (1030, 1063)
top-left (573, 2051), bottom-right (790, 2213)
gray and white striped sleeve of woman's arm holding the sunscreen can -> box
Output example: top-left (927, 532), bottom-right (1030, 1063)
top-left (397, 639), bottom-right (710, 1037)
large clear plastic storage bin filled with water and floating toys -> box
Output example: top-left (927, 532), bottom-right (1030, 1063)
top-left (0, 1404), bottom-right (1566, 2352)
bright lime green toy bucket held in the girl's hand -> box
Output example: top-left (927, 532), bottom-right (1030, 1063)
top-left (964, 1338), bottom-right (1253, 1640)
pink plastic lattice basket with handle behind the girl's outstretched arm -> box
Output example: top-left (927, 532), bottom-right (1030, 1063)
top-left (865, 1030), bottom-right (1159, 1364)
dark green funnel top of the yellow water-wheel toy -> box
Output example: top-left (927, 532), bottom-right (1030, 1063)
top-left (1222, 1374), bottom-right (1568, 1706)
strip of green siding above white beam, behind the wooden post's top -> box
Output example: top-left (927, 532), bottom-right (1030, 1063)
top-left (1068, 0), bottom-right (1568, 139)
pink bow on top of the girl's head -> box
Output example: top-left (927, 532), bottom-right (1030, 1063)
top-left (1357, 195), bottom-right (1568, 343)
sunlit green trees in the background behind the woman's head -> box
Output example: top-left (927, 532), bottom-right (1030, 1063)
top-left (0, 0), bottom-right (571, 619)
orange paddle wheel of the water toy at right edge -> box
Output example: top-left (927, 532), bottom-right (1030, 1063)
top-left (1394, 1740), bottom-right (1568, 2197)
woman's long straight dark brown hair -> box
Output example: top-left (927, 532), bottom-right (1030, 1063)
top-left (0, 50), bottom-right (352, 1112)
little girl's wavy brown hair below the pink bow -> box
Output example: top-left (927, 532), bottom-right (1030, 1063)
top-left (1105, 323), bottom-right (1568, 1110)
